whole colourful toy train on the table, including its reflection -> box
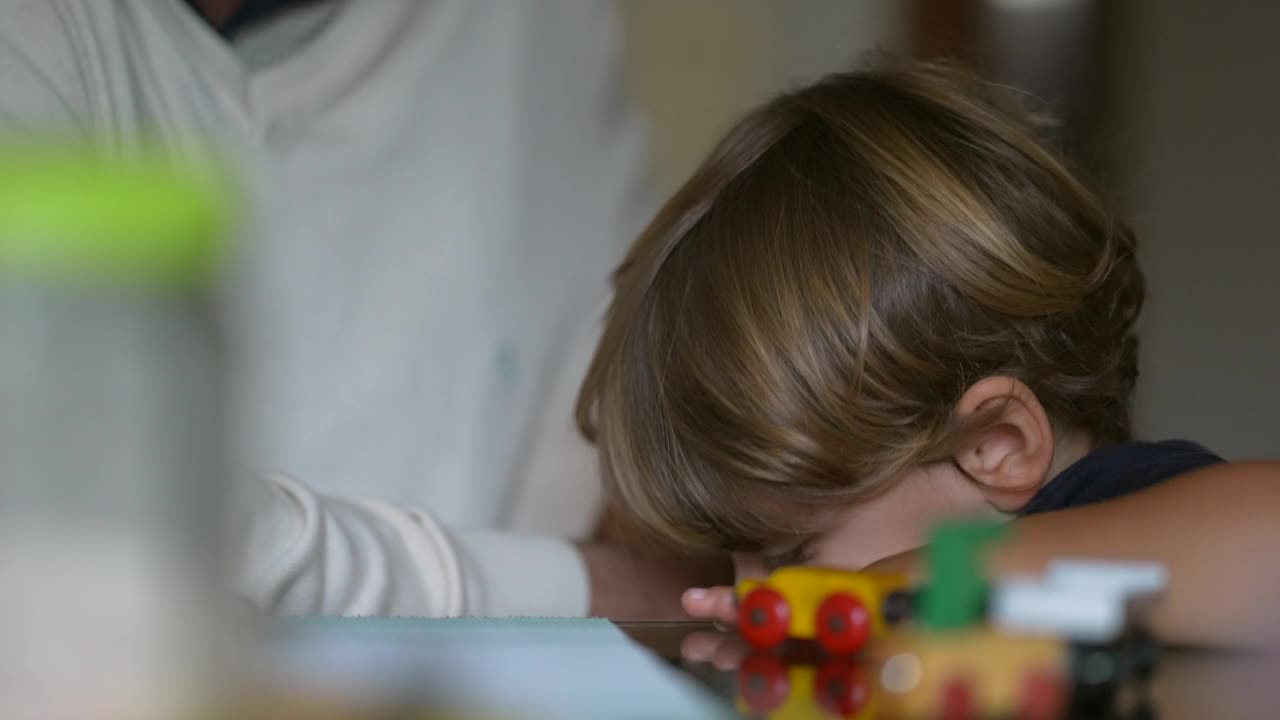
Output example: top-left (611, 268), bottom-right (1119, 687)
top-left (739, 520), bottom-right (1167, 720)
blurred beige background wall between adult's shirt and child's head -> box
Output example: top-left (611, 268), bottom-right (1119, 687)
top-left (622, 0), bottom-right (902, 197)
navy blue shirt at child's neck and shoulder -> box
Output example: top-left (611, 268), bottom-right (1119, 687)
top-left (1019, 439), bottom-right (1222, 515)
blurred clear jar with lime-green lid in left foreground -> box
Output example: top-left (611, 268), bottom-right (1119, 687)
top-left (0, 143), bottom-right (229, 719)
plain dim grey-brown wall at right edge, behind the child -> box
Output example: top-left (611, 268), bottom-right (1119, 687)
top-left (1116, 0), bottom-right (1280, 457)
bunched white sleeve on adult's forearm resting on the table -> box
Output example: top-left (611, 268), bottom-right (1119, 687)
top-left (238, 475), bottom-right (589, 616)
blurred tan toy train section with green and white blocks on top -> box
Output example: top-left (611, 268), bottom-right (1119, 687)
top-left (874, 524), bottom-right (1167, 719)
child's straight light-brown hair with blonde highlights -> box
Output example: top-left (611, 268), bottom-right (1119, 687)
top-left (577, 58), bottom-right (1143, 550)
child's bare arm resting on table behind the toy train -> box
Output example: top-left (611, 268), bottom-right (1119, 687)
top-left (874, 462), bottom-right (1280, 648)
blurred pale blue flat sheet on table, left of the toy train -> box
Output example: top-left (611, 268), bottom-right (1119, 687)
top-left (258, 618), bottom-right (732, 720)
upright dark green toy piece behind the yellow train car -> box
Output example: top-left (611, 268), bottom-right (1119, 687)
top-left (920, 520), bottom-right (1009, 630)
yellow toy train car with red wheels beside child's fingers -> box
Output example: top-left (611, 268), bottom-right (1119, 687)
top-left (737, 566), bottom-right (911, 655)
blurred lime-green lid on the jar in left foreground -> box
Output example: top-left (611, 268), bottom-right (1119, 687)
top-left (0, 141), bottom-right (233, 286)
